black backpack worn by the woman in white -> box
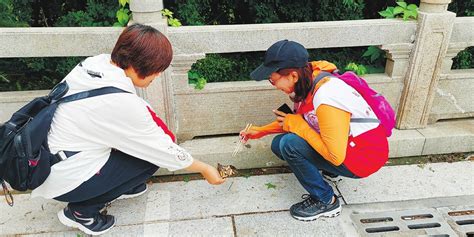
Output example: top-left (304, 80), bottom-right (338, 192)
top-left (0, 82), bottom-right (128, 206)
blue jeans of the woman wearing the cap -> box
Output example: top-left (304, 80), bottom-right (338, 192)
top-left (271, 133), bottom-right (358, 203)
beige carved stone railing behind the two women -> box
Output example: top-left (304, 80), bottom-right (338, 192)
top-left (0, 0), bottom-right (474, 141)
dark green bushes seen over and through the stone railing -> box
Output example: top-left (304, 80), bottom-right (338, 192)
top-left (0, 0), bottom-right (474, 91)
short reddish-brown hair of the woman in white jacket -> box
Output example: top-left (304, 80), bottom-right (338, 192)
top-left (112, 24), bottom-right (173, 78)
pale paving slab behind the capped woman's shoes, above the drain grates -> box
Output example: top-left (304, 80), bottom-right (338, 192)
top-left (337, 161), bottom-right (474, 204)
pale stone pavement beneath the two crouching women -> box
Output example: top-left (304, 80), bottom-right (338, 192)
top-left (0, 161), bottom-right (474, 236)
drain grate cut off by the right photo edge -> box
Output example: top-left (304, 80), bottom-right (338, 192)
top-left (438, 206), bottom-right (474, 237)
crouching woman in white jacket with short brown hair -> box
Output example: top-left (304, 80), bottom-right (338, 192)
top-left (32, 24), bottom-right (224, 235)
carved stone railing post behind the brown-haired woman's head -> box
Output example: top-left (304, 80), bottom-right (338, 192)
top-left (129, 0), bottom-right (172, 123)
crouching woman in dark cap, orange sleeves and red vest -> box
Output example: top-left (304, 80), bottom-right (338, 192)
top-left (240, 40), bottom-right (388, 221)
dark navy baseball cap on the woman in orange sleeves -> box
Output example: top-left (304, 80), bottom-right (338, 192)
top-left (250, 40), bottom-right (309, 81)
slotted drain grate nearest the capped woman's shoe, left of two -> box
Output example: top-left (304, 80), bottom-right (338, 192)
top-left (351, 209), bottom-right (456, 237)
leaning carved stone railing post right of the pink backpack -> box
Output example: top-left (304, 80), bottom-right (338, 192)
top-left (397, 0), bottom-right (456, 129)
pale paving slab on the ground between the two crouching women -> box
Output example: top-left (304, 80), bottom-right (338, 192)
top-left (150, 174), bottom-right (337, 220)
